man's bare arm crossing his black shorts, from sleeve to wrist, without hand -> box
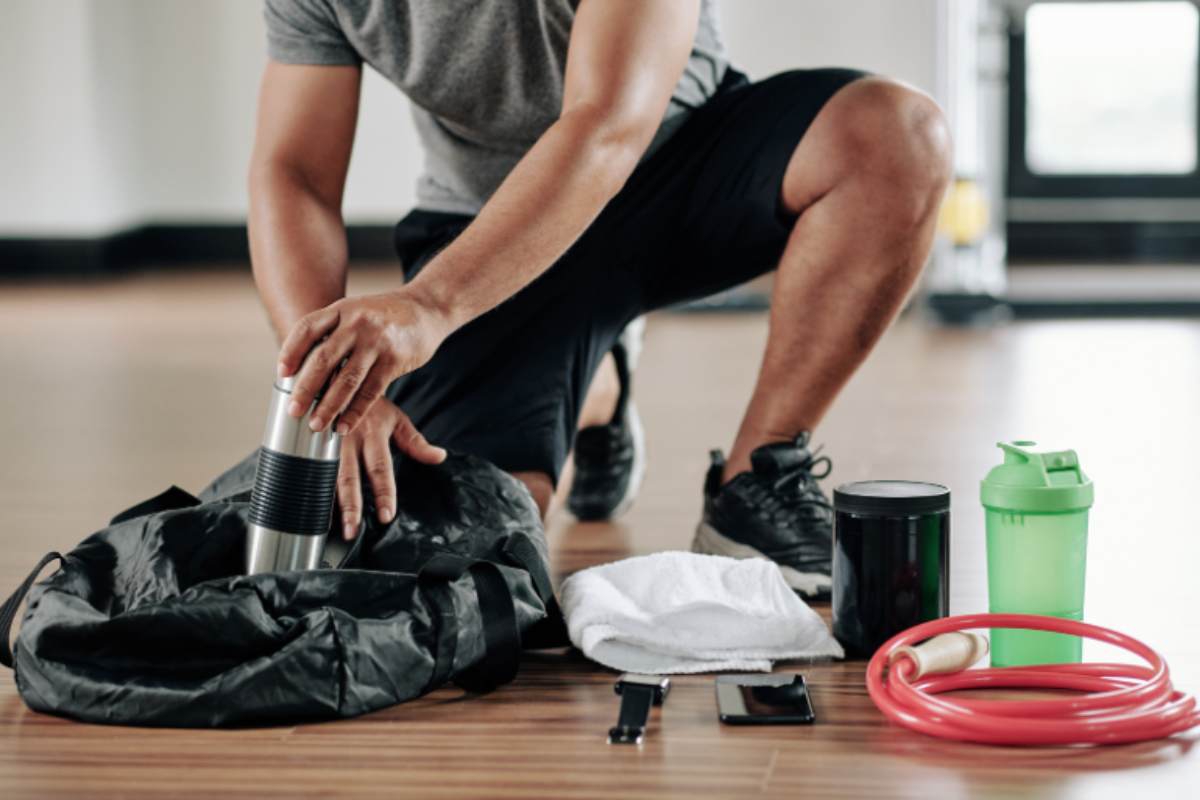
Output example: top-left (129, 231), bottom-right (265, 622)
top-left (403, 0), bottom-right (700, 327)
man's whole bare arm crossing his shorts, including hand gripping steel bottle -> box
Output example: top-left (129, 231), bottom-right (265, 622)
top-left (280, 0), bottom-right (700, 431)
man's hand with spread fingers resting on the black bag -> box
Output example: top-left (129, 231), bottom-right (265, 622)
top-left (337, 399), bottom-right (446, 539)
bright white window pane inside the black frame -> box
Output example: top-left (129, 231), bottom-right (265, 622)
top-left (1025, 1), bottom-right (1200, 175)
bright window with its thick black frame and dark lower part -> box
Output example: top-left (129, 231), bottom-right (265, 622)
top-left (1008, 0), bottom-right (1200, 263)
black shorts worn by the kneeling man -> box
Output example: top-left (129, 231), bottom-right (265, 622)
top-left (389, 70), bottom-right (863, 481)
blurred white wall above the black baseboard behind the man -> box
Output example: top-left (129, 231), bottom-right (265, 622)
top-left (0, 0), bottom-right (938, 236)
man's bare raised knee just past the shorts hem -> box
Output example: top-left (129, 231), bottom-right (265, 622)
top-left (801, 78), bottom-right (953, 224)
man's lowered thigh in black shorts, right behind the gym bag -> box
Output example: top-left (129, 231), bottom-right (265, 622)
top-left (388, 212), bottom-right (642, 482)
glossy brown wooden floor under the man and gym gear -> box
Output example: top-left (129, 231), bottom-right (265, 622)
top-left (0, 266), bottom-right (1200, 800)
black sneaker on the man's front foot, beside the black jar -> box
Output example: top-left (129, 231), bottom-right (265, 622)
top-left (691, 432), bottom-right (833, 600)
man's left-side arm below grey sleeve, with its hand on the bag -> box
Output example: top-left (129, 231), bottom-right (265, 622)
top-left (250, 62), bottom-right (445, 539)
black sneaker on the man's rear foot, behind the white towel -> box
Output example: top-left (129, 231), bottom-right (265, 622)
top-left (566, 336), bottom-right (646, 521)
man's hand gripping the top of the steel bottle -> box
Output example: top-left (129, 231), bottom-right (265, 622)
top-left (280, 287), bottom-right (452, 434)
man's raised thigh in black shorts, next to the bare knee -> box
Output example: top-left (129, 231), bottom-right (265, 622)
top-left (577, 70), bottom-right (863, 309)
